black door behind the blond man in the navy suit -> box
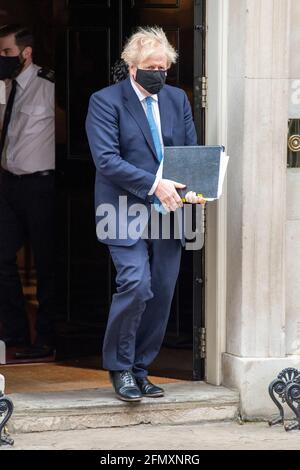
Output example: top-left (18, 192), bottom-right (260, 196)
top-left (54, 0), bottom-right (204, 379)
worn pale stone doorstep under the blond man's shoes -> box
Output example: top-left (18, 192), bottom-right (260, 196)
top-left (8, 381), bottom-right (239, 433)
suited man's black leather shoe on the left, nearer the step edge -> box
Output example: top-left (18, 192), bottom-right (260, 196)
top-left (109, 370), bottom-right (143, 401)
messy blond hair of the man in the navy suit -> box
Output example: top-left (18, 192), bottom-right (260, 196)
top-left (121, 26), bottom-right (178, 68)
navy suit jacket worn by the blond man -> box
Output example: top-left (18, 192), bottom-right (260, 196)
top-left (86, 78), bottom-right (197, 246)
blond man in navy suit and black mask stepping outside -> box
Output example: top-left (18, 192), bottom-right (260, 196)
top-left (86, 28), bottom-right (204, 401)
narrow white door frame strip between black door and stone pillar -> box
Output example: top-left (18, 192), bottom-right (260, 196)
top-left (205, 0), bottom-right (228, 385)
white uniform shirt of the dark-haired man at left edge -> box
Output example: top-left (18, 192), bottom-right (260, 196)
top-left (0, 64), bottom-right (55, 175)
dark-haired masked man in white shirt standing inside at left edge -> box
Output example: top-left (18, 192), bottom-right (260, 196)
top-left (0, 25), bottom-right (55, 359)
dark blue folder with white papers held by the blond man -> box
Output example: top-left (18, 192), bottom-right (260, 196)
top-left (162, 146), bottom-right (228, 199)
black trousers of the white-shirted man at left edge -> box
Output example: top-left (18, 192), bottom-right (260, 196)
top-left (0, 172), bottom-right (55, 340)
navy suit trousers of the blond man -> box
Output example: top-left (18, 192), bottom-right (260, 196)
top-left (103, 234), bottom-right (182, 377)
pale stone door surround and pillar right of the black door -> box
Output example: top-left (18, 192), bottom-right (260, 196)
top-left (205, 0), bottom-right (300, 419)
